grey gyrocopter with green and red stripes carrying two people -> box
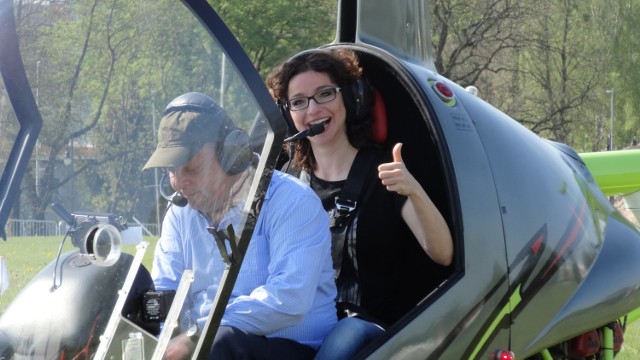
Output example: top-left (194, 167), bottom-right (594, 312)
top-left (0, 0), bottom-right (640, 359)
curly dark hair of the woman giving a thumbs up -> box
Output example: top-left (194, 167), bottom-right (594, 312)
top-left (267, 48), bottom-right (373, 172)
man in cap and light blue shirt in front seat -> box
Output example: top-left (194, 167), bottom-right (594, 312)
top-left (144, 93), bottom-right (337, 359)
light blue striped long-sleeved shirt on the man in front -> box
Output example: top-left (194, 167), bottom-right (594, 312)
top-left (151, 171), bottom-right (337, 349)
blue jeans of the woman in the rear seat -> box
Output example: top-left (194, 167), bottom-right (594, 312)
top-left (315, 317), bottom-right (384, 360)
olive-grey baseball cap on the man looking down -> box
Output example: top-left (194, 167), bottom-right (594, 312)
top-left (142, 92), bottom-right (232, 170)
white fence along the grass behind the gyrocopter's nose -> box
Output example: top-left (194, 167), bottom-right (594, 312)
top-left (5, 219), bottom-right (160, 237)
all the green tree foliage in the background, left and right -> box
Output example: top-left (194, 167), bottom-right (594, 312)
top-left (6, 0), bottom-right (640, 219)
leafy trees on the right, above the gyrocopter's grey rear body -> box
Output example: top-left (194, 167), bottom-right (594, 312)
top-left (431, 0), bottom-right (639, 151)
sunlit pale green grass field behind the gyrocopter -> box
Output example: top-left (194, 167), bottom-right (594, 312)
top-left (0, 237), bottom-right (640, 360)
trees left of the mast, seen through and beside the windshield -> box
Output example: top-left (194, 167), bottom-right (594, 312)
top-left (11, 0), bottom-right (335, 224)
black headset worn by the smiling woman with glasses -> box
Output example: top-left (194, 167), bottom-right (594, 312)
top-left (276, 49), bottom-right (373, 134)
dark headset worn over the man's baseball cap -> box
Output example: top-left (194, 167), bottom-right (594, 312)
top-left (163, 92), bottom-right (253, 175)
